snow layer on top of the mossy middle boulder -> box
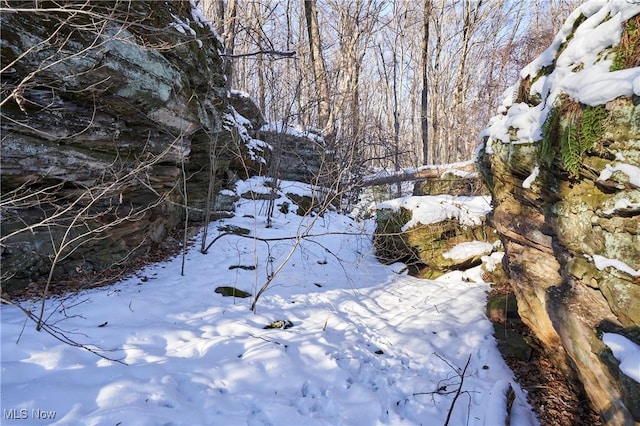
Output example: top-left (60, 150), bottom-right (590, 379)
top-left (377, 195), bottom-right (491, 231)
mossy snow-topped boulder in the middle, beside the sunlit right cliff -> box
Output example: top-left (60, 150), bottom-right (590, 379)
top-left (364, 162), bottom-right (498, 279)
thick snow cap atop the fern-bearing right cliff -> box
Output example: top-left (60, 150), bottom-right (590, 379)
top-left (481, 0), bottom-right (640, 154)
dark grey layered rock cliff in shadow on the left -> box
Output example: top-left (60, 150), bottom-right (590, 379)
top-left (0, 1), bottom-right (264, 290)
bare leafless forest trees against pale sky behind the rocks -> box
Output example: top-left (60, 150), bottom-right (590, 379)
top-left (202, 0), bottom-right (580, 170)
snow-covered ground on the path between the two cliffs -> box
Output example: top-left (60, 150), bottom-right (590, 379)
top-left (1, 178), bottom-right (537, 426)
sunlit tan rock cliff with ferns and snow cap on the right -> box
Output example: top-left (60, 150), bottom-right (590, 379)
top-left (478, 0), bottom-right (640, 425)
